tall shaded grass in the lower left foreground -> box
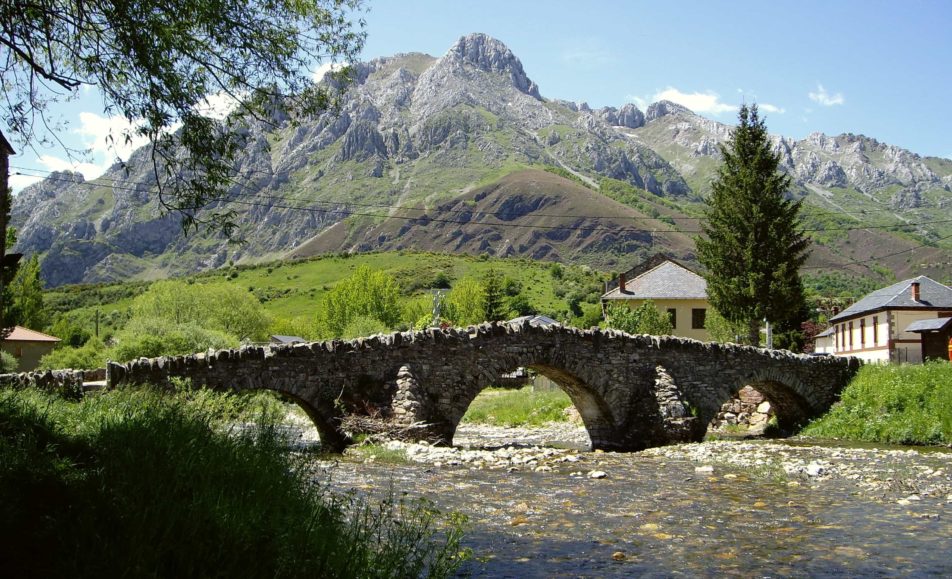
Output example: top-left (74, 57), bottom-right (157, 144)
top-left (0, 390), bottom-right (461, 577)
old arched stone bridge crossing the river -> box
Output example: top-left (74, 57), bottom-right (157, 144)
top-left (107, 323), bottom-right (859, 451)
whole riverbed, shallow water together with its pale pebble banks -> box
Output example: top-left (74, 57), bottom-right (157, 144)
top-left (302, 423), bottom-right (952, 578)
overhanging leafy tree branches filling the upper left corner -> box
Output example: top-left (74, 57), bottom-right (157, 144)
top-left (0, 0), bottom-right (365, 236)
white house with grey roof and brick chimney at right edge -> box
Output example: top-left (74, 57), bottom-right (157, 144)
top-left (830, 276), bottom-right (952, 362)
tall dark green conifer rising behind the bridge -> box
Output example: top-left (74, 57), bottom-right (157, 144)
top-left (695, 105), bottom-right (810, 346)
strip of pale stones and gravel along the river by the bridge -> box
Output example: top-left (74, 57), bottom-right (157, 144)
top-left (352, 423), bottom-right (952, 505)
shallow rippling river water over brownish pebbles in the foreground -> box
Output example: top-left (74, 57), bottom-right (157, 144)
top-left (310, 426), bottom-right (952, 577)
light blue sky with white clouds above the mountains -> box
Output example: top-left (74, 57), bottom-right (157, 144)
top-left (10, 0), bottom-right (952, 191)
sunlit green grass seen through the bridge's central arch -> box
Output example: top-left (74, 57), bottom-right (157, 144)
top-left (463, 387), bottom-right (572, 426)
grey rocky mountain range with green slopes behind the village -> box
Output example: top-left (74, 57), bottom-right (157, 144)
top-left (13, 34), bottom-right (952, 286)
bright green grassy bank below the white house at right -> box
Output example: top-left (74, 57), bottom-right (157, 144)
top-left (802, 362), bottom-right (952, 444)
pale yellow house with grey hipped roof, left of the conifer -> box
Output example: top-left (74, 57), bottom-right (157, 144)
top-left (602, 255), bottom-right (711, 342)
